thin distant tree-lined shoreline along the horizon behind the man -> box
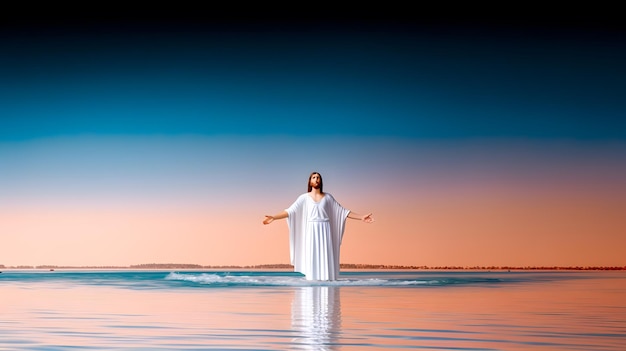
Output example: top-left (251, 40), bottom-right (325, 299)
top-left (0, 263), bottom-right (626, 271)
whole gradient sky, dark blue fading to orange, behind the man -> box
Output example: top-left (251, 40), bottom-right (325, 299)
top-left (0, 10), bottom-right (626, 266)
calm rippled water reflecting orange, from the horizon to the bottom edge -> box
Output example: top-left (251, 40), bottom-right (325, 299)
top-left (0, 270), bottom-right (626, 351)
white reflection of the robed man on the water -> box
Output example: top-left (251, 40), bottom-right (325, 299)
top-left (291, 286), bottom-right (341, 351)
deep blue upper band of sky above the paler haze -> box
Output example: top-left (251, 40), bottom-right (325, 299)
top-left (0, 7), bottom-right (626, 140)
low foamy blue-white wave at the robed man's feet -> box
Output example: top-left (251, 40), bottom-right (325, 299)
top-left (165, 272), bottom-right (499, 287)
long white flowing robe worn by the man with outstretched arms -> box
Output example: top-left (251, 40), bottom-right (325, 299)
top-left (285, 193), bottom-right (350, 280)
